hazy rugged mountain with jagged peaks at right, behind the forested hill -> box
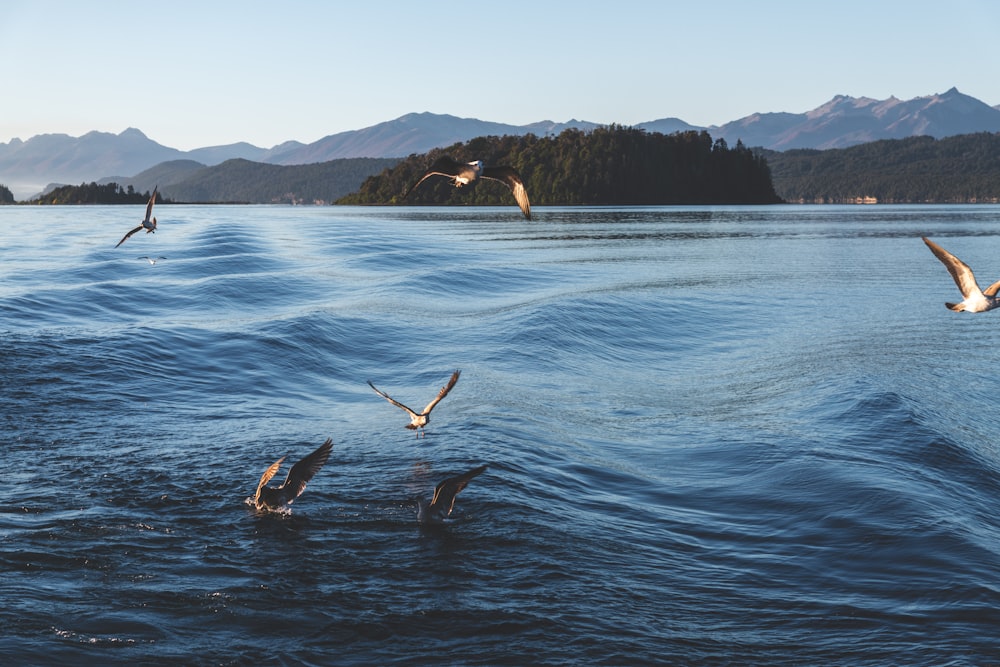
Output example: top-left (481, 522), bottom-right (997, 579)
top-left (708, 88), bottom-right (1000, 151)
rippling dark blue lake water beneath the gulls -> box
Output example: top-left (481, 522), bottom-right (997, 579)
top-left (0, 206), bottom-right (1000, 665)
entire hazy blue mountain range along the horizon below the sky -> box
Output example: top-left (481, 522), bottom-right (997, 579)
top-left (0, 88), bottom-right (1000, 199)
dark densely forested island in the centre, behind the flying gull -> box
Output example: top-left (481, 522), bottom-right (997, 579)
top-left (337, 125), bottom-right (780, 204)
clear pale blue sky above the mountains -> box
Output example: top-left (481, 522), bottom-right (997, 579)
top-left (0, 0), bottom-right (1000, 150)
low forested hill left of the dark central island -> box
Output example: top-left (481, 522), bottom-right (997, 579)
top-left (164, 158), bottom-right (399, 204)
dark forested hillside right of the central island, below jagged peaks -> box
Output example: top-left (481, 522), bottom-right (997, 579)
top-left (764, 133), bottom-right (1000, 204)
